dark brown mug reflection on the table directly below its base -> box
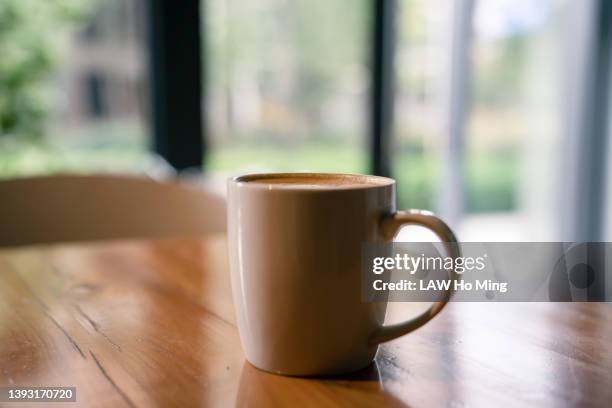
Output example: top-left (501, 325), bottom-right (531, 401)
top-left (236, 360), bottom-right (408, 407)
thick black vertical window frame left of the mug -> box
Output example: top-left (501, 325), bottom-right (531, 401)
top-left (146, 0), bottom-right (207, 171)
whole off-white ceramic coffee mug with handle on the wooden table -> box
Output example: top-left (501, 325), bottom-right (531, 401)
top-left (228, 173), bottom-right (459, 376)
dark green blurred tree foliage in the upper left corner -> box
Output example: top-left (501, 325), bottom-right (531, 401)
top-left (0, 0), bottom-right (91, 139)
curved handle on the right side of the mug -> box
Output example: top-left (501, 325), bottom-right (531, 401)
top-left (370, 210), bottom-right (461, 344)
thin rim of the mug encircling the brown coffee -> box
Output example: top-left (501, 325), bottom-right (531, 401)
top-left (228, 172), bottom-right (395, 191)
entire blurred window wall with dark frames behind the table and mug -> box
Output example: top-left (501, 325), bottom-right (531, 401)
top-left (0, 0), bottom-right (612, 241)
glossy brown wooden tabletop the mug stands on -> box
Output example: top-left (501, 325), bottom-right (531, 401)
top-left (0, 236), bottom-right (612, 407)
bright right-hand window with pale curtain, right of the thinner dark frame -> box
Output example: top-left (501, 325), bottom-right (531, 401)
top-left (393, 0), bottom-right (608, 241)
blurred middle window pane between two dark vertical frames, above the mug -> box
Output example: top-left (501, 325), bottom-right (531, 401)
top-left (204, 0), bottom-right (370, 172)
